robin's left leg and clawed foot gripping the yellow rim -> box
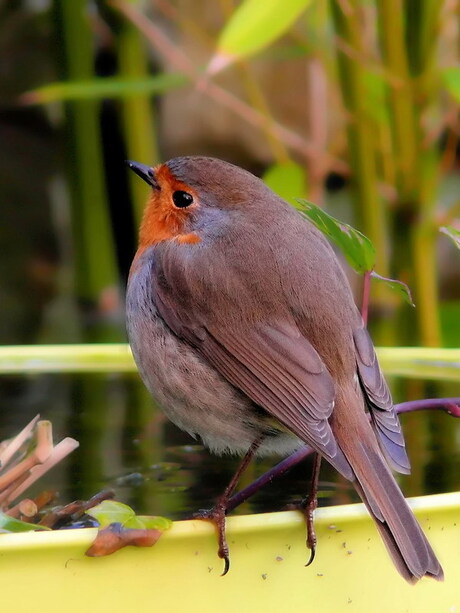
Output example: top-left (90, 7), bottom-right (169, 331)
top-left (194, 436), bottom-right (264, 576)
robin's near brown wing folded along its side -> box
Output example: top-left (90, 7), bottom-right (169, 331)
top-left (153, 253), bottom-right (353, 479)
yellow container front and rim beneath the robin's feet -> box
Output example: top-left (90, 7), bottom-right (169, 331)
top-left (0, 492), bottom-right (460, 613)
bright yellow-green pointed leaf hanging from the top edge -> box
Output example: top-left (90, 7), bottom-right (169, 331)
top-left (212, 0), bottom-right (311, 67)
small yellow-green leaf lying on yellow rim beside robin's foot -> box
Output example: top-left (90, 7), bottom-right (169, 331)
top-left (86, 500), bottom-right (172, 530)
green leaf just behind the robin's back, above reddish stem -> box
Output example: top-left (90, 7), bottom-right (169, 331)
top-left (297, 199), bottom-right (375, 274)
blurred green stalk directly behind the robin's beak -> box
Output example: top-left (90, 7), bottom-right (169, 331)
top-left (117, 0), bottom-right (160, 227)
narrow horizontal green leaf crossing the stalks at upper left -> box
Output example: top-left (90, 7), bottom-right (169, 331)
top-left (20, 73), bottom-right (187, 104)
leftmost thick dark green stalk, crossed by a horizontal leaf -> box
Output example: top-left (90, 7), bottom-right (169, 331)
top-left (54, 0), bottom-right (118, 330)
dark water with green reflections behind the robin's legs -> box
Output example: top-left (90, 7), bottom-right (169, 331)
top-left (0, 374), bottom-right (460, 519)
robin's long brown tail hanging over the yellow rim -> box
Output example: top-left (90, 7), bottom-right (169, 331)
top-left (334, 390), bottom-right (444, 583)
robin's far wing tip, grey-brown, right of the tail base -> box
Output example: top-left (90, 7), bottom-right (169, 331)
top-left (353, 328), bottom-right (410, 474)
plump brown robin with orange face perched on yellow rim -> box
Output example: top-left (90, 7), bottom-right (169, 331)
top-left (126, 156), bottom-right (443, 583)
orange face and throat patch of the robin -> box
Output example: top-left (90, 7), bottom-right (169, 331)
top-left (139, 164), bottom-right (201, 253)
